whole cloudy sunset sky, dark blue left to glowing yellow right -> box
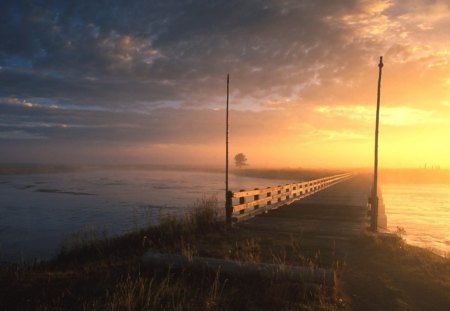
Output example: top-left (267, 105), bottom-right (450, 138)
top-left (0, 0), bottom-right (450, 168)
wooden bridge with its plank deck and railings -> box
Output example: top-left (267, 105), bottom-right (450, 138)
top-left (232, 173), bottom-right (386, 239)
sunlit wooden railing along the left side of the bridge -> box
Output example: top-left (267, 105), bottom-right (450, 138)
top-left (229, 173), bottom-right (353, 222)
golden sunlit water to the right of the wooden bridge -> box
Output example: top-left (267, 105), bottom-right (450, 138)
top-left (382, 184), bottom-right (450, 257)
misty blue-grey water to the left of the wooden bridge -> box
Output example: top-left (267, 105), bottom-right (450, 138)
top-left (0, 170), bottom-right (288, 262)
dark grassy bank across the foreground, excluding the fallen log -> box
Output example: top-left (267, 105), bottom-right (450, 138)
top-left (0, 198), bottom-right (450, 310)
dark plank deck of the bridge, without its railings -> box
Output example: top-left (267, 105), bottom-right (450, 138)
top-left (240, 176), bottom-right (370, 238)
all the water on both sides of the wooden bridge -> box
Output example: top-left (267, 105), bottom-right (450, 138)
top-left (0, 170), bottom-right (450, 262)
